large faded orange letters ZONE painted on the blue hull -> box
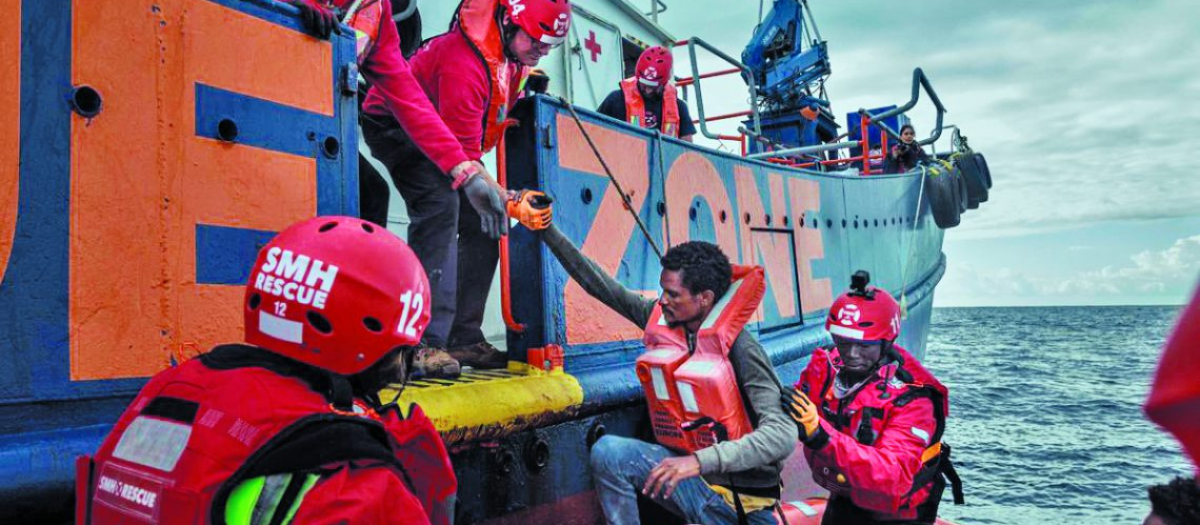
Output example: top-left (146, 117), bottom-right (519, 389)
top-left (558, 115), bottom-right (833, 344)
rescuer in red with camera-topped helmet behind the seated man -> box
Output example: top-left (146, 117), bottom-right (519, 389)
top-left (784, 271), bottom-right (962, 525)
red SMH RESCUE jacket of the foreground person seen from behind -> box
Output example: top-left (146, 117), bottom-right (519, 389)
top-left (76, 345), bottom-right (457, 525)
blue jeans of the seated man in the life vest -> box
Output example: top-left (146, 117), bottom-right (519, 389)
top-left (592, 435), bottom-right (775, 525)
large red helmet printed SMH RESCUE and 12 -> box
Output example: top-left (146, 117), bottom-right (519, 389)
top-left (245, 217), bottom-right (430, 375)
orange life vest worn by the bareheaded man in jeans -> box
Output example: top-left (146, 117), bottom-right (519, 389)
top-left (636, 266), bottom-right (766, 452)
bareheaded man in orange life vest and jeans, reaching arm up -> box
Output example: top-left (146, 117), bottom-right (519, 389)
top-left (510, 194), bottom-right (796, 525)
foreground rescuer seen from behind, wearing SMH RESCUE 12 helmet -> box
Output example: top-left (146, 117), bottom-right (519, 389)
top-left (77, 217), bottom-right (457, 525)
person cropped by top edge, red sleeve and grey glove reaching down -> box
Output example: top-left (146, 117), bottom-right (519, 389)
top-left (293, 0), bottom-right (508, 234)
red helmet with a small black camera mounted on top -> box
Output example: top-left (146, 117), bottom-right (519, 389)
top-left (826, 270), bottom-right (900, 343)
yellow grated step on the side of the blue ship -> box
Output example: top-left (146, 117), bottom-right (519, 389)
top-left (379, 362), bottom-right (583, 446)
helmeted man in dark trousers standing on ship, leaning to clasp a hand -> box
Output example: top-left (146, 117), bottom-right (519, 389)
top-left (352, 0), bottom-right (571, 378)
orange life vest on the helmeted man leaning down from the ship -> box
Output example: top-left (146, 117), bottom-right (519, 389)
top-left (455, 0), bottom-right (529, 152)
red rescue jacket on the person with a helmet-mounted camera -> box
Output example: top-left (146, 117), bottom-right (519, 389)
top-left (796, 346), bottom-right (961, 523)
